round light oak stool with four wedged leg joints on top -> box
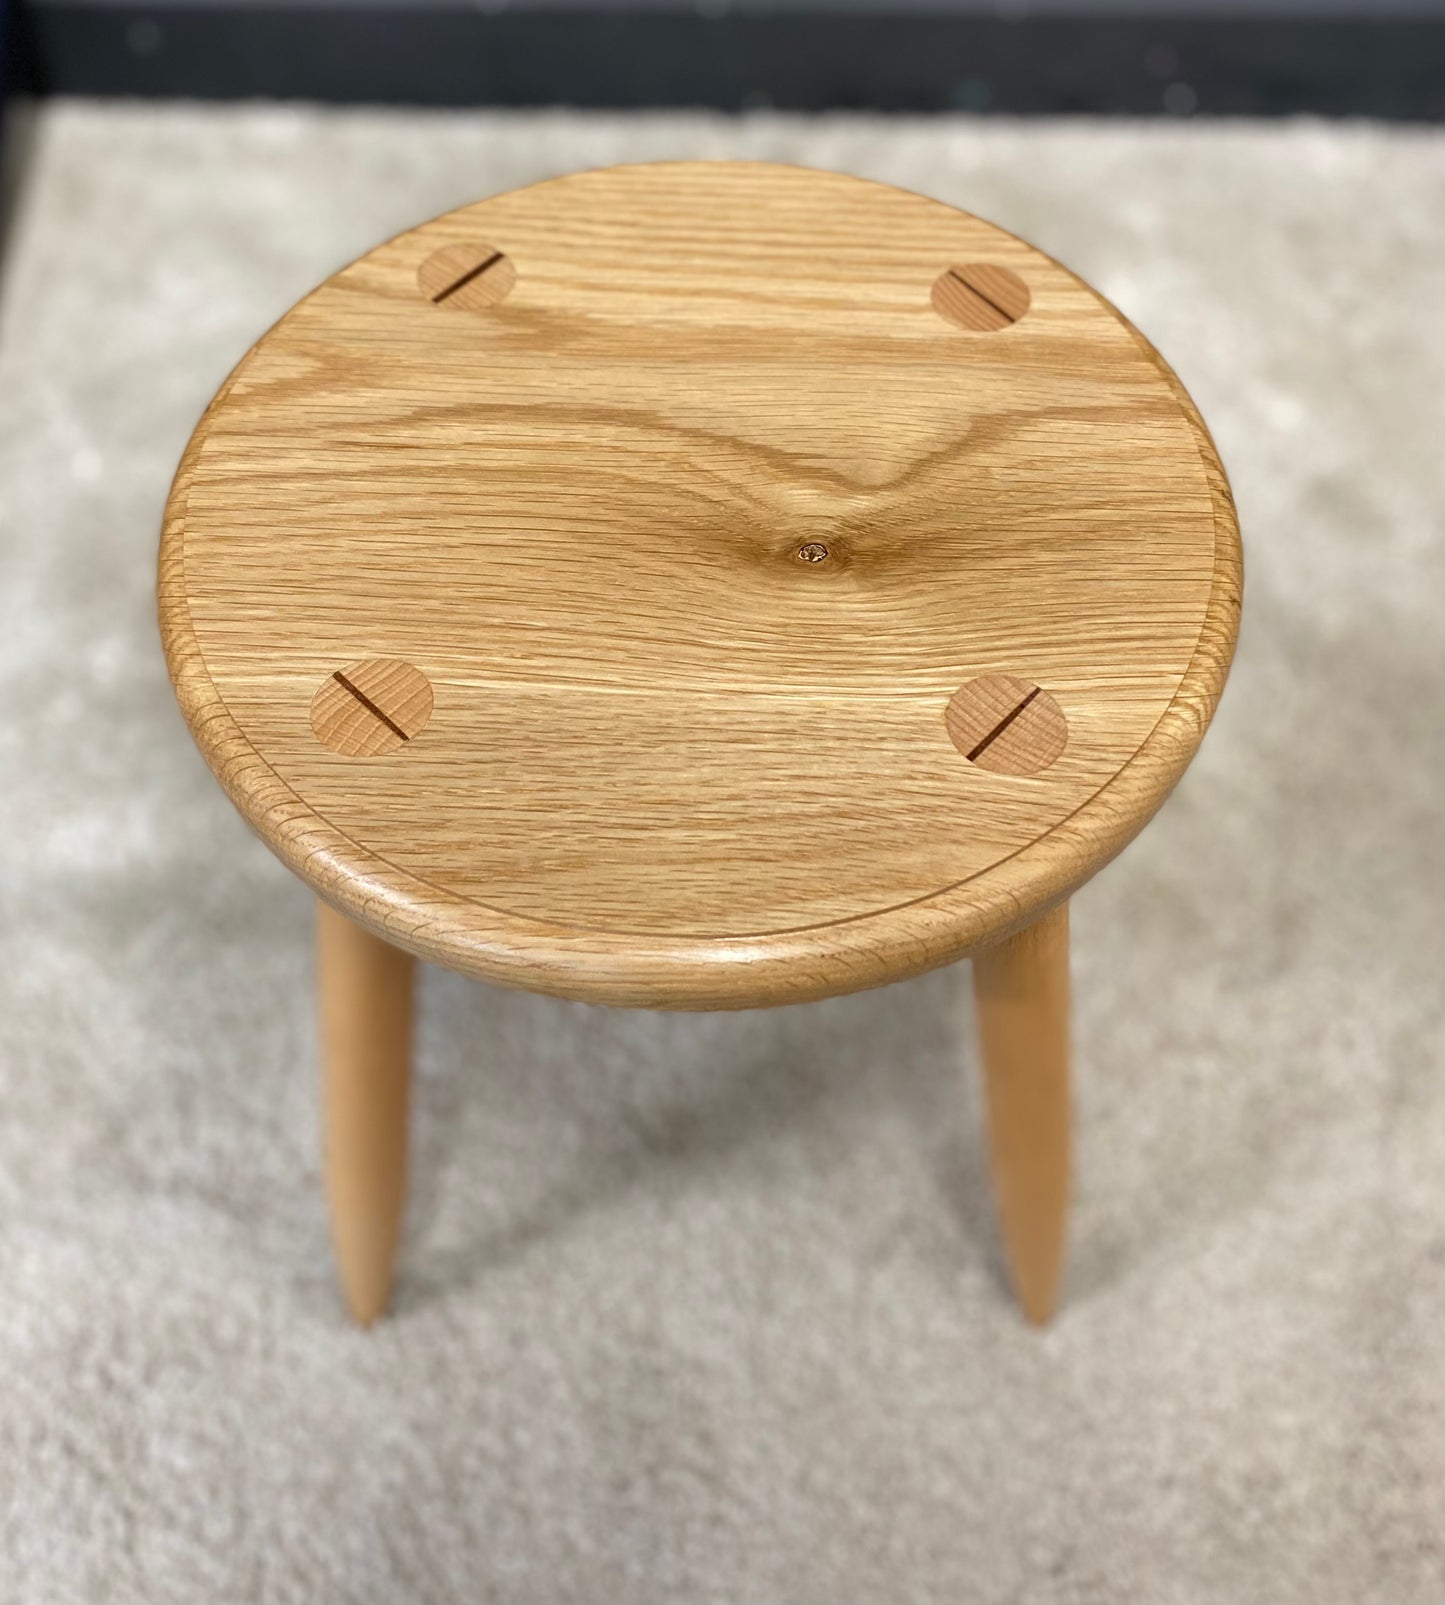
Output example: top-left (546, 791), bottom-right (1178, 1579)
top-left (161, 164), bottom-right (1241, 1323)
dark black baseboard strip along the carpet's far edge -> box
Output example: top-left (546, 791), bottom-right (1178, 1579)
top-left (16, 0), bottom-right (1445, 120)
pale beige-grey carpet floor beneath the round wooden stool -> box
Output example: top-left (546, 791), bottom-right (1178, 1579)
top-left (0, 103), bottom-right (1445, 1605)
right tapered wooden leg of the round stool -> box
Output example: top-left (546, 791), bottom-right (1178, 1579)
top-left (973, 904), bottom-right (1069, 1324)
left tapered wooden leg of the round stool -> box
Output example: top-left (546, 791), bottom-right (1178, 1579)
top-left (316, 904), bottom-right (413, 1326)
